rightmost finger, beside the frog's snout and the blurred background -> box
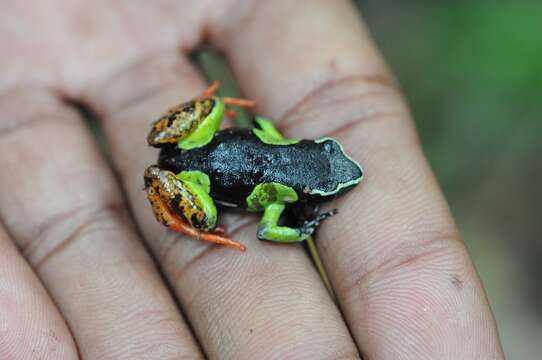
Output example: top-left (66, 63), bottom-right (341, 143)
top-left (210, 1), bottom-right (502, 359)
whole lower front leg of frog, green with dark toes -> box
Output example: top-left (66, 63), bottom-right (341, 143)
top-left (247, 183), bottom-right (335, 243)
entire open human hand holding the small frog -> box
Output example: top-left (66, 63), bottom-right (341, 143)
top-left (0, 0), bottom-right (503, 359)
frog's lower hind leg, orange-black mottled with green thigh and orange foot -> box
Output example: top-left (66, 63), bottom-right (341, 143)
top-left (145, 165), bottom-right (246, 251)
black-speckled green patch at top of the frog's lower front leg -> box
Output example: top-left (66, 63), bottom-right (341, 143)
top-left (247, 183), bottom-right (297, 211)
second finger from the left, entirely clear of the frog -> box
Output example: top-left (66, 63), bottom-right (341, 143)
top-left (0, 89), bottom-right (202, 359)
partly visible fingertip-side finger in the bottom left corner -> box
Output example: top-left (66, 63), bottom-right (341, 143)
top-left (0, 228), bottom-right (78, 359)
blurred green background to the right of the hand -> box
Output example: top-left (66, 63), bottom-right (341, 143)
top-left (356, 0), bottom-right (542, 359)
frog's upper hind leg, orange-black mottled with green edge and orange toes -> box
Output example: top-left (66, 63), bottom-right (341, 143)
top-left (147, 82), bottom-right (255, 150)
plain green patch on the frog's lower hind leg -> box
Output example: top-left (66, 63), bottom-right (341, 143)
top-left (181, 171), bottom-right (217, 229)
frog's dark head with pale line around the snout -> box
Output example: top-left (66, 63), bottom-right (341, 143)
top-left (311, 137), bottom-right (363, 197)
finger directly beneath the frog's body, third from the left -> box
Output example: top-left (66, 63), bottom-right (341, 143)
top-left (88, 52), bottom-right (358, 359)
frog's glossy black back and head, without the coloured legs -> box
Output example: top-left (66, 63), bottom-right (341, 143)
top-left (158, 128), bottom-right (362, 208)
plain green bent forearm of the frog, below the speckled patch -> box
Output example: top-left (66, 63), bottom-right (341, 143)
top-left (258, 203), bottom-right (310, 243)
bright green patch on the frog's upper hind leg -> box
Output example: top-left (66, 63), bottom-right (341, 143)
top-left (177, 97), bottom-right (225, 150)
